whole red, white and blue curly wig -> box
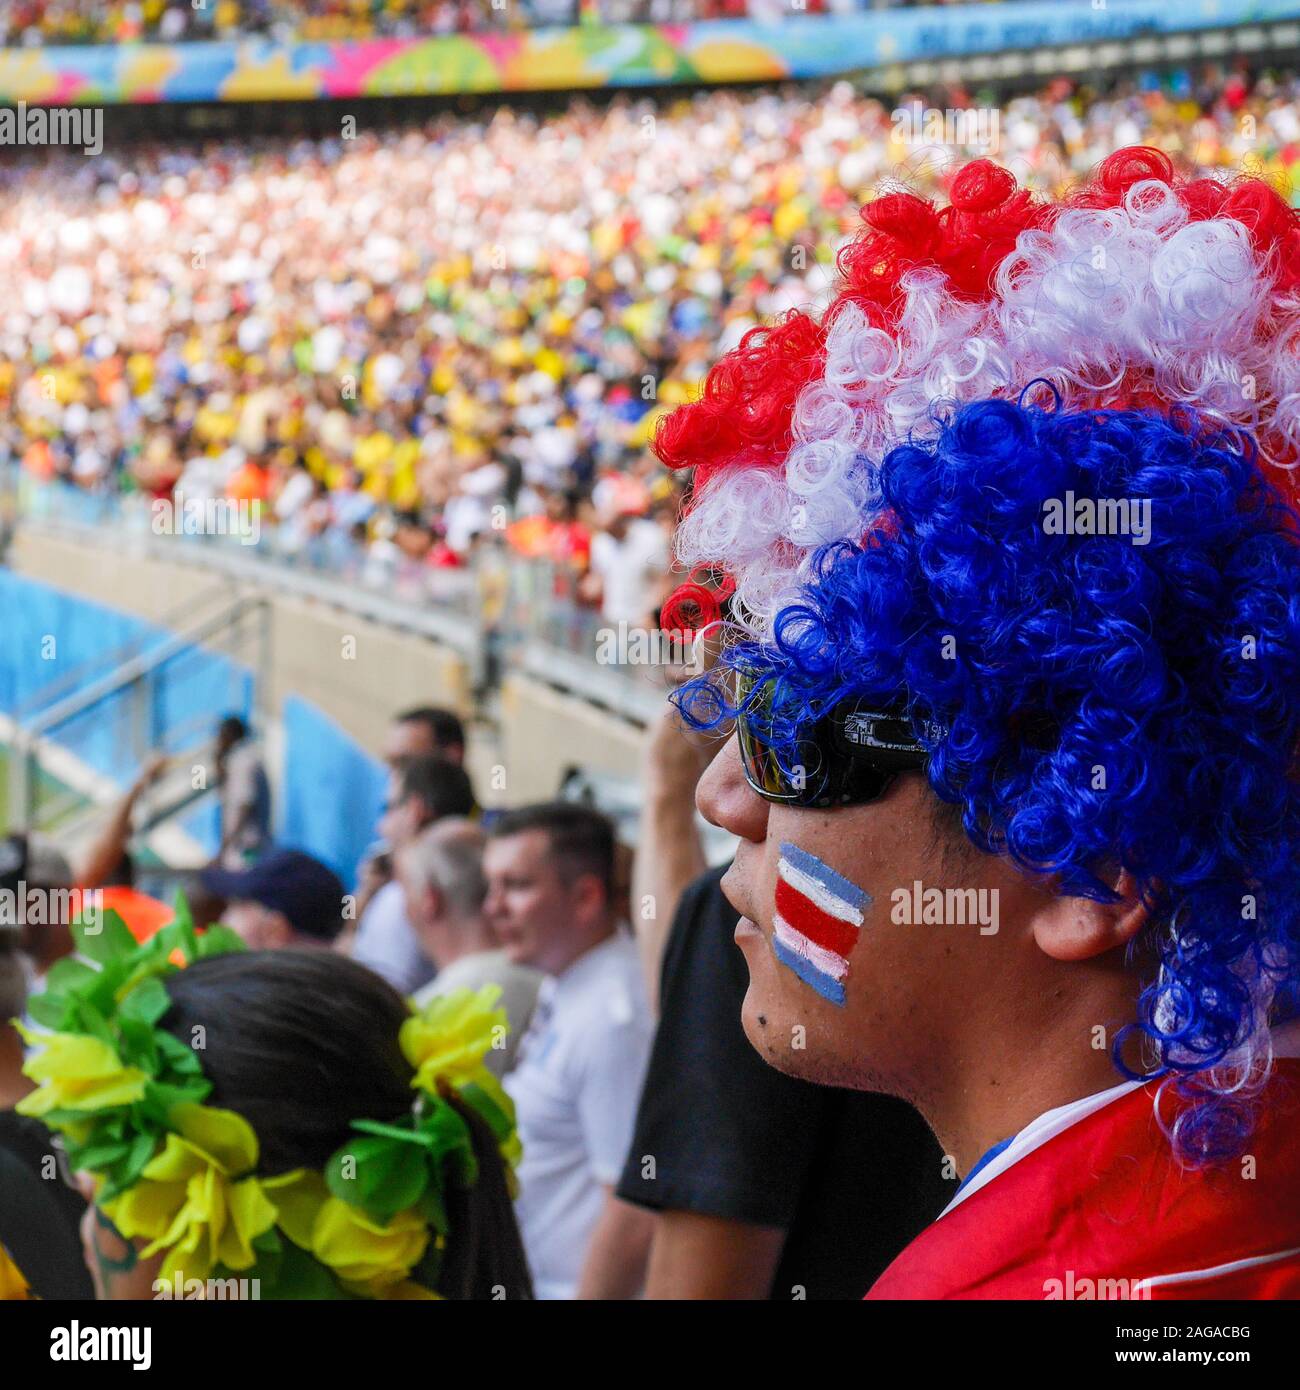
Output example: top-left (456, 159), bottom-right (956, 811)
top-left (656, 149), bottom-right (1300, 1162)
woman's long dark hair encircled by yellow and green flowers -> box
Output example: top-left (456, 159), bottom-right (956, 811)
top-left (161, 949), bottom-right (533, 1298)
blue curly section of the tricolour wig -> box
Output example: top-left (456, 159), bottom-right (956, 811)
top-left (674, 400), bottom-right (1300, 1166)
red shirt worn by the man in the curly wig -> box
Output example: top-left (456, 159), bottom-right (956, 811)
top-left (868, 1036), bottom-right (1300, 1300)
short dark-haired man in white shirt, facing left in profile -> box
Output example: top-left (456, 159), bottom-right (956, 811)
top-left (484, 802), bottom-right (653, 1298)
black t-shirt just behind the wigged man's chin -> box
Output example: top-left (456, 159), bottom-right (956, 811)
top-left (619, 869), bottom-right (957, 1298)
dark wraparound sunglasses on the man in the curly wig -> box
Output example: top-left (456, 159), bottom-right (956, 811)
top-left (736, 671), bottom-right (947, 809)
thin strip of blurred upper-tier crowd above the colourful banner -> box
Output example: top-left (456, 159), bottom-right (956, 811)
top-left (0, 0), bottom-right (995, 46)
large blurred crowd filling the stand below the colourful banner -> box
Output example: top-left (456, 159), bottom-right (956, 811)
top-left (0, 72), bottom-right (1300, 621)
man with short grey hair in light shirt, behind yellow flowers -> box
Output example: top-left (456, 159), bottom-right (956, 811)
top-left (396, 816), bottom-right (542, 1076)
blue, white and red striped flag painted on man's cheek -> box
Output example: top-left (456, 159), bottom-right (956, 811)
top-left (772, 844), bottom-right (872, 1008)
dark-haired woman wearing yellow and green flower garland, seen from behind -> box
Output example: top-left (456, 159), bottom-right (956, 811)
top-left (19, 912), bottom-right (531, 1300)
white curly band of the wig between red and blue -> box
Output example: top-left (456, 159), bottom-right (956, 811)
top-left (677, 179), bottom-right (1300, 639)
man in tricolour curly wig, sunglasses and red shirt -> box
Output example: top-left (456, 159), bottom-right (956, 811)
top-left (656, 149), bottom-right (1300, 1298)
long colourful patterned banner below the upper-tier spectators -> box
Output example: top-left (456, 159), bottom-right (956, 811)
top-left (0, 0), bottom-right (1300, 106)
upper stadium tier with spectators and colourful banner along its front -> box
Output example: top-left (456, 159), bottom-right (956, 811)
top-left (0, 0), bottom-right (1300, 105)
